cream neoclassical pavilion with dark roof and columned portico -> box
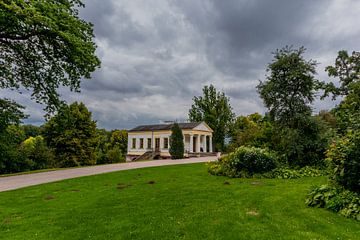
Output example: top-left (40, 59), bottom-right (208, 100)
top-left (127, 122), bottom-right (213, 160)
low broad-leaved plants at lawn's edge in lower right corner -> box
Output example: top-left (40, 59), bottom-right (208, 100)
top-left (306, 185), bottom-right (360, 221)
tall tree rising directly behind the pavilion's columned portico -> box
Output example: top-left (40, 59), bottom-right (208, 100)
top-left (189, 85), bottom-right (235, 151)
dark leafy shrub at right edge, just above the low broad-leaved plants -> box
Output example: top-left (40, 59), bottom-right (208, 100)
top-left (326, 131), bottom-right (360, 193)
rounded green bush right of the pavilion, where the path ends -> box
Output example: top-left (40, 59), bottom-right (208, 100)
top-left (228, 146), bottom-right (276, 177)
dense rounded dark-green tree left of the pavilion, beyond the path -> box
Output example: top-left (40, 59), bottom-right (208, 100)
top-left (44, 102), bottom-right (98, 167)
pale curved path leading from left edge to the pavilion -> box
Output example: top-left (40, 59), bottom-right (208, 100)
top-left (0, 156), bottom-right (217, 192)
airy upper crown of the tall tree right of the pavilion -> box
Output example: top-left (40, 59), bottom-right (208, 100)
top-left (257, 46), bottom-right (319, 127)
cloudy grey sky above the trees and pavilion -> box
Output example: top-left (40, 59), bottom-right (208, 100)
top-left (0, 0), bottom-right (360, 130)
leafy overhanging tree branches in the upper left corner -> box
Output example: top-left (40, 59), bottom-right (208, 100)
top-left (0, 0), bottom-right (100, 111)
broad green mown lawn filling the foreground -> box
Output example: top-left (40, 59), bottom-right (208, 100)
top-left (0, 164), bottom-right (360, 240)
